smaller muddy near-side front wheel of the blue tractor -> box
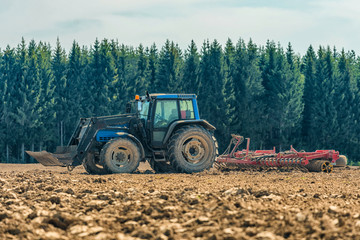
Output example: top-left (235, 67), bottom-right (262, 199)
top-left (100, 138), bottom-right (141, 173)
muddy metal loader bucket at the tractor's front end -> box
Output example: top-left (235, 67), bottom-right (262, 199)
top-left (26, 146), bottom-right (76, 167)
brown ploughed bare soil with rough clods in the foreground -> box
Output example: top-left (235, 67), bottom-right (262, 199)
top-left (0, 164), bottom-right (360, 240)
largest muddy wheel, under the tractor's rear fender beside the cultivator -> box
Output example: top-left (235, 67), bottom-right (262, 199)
top-left (167, 126), bottom-right (216, 173)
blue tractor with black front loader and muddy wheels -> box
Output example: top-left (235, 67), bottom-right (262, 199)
top-left (27, 93), bottom-right (217, 174)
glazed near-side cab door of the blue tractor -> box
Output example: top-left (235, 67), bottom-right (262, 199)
top-left (152, 99), bottom-right (180, 148)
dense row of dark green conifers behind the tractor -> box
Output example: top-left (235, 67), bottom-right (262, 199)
top-left (0, 39), bottom-right (360, 164)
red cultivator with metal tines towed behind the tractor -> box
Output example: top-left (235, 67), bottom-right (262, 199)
top-left (216, 134), bottom-right (347, 173)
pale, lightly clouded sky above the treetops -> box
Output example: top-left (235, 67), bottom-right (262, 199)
top-left (0, 0), bottom-right (360, 55)
